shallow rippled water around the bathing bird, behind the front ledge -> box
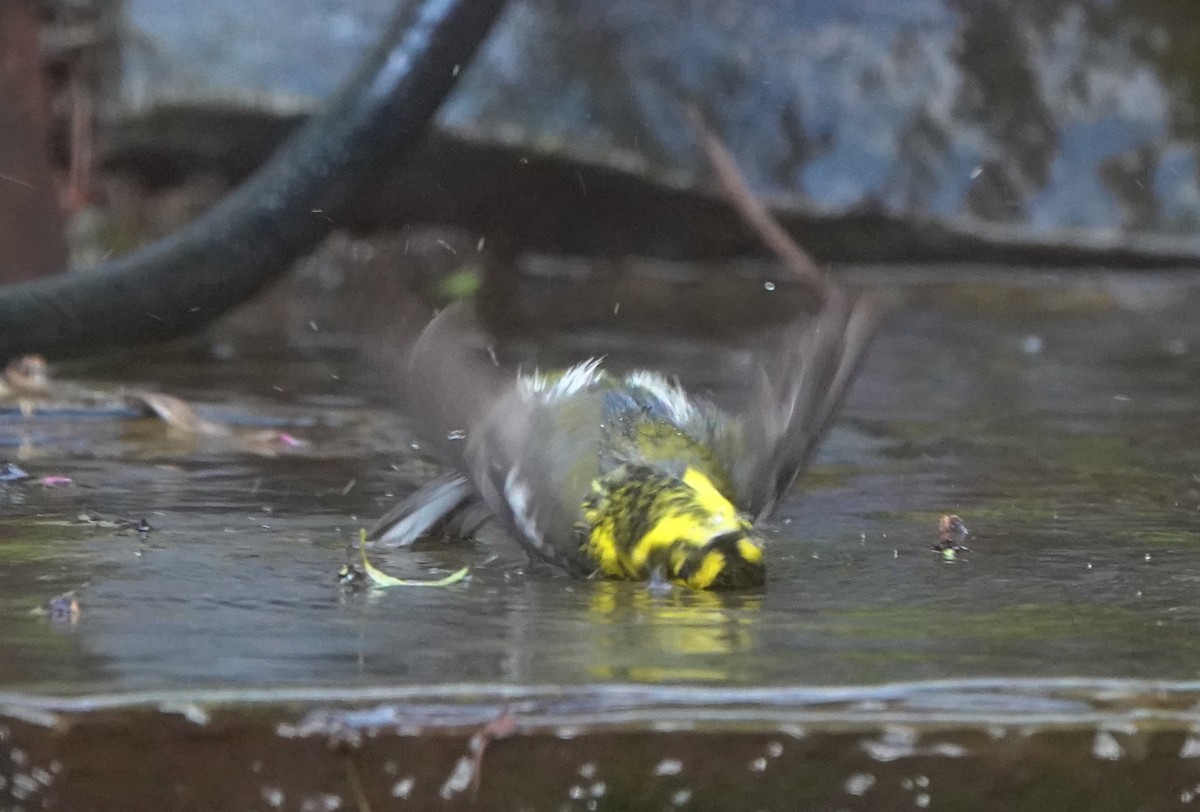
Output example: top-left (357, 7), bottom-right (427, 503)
top-left (0, 271), bottom-right (1200, 694)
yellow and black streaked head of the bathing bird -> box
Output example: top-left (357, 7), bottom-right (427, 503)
top-left (580, 465), bottom-right (766, 589)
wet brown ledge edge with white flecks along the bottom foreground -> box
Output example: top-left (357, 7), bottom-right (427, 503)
top-left (7, 680), bottom-right (1200, 810)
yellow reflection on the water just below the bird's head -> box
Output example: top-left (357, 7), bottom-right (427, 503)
top-left (588, 581), bottom-right (762, 682)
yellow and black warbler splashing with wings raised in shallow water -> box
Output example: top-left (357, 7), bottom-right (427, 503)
top-left (370, 288), bottom-right (874, 589)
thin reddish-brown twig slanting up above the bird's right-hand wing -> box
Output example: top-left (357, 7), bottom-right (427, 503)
top-left (685, 104), bottom-right (829, 297)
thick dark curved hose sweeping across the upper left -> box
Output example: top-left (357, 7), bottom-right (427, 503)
top-left (0, 0), bottom-right (504, 362)
